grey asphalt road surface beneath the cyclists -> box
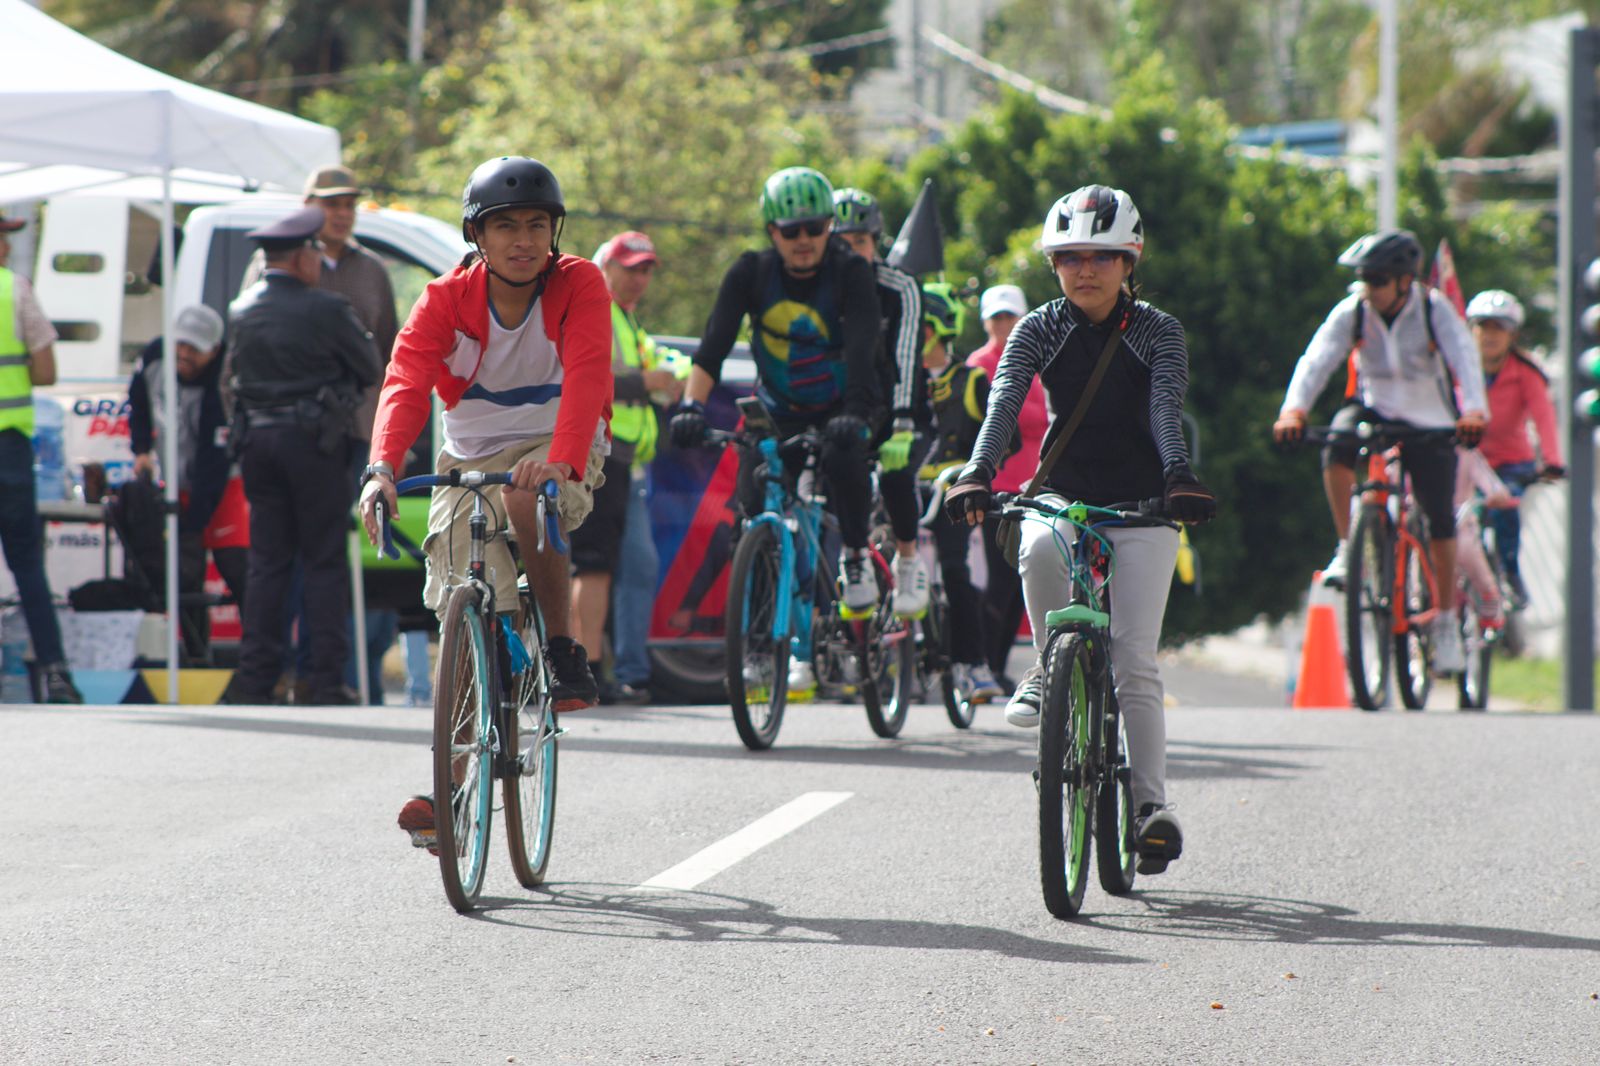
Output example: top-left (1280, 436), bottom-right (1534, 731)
top-left (0, 675), bottom-right (1600, 1064)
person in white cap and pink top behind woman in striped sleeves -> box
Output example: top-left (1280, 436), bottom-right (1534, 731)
top-left (966, 285), bottom-right (1050, 693)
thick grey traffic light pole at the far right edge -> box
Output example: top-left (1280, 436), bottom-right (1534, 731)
top-left (1557, 29), bottom-right (1600, 711)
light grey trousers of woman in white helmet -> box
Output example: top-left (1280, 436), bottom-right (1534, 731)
top-left (1018, 496), bottom-right (1178, 807)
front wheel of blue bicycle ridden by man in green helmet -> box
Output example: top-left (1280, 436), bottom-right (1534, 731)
top-left (723, 525), bottom-right (790, 751)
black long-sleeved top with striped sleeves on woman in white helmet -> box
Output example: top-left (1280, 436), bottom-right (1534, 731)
top-left (966, 296), bottom-right (1189, 504)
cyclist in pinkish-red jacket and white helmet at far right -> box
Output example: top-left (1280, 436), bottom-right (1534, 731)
top-left (1467, 288), bottom-right (1566, 607)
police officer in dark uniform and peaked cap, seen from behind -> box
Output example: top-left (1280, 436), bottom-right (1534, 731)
top-left (224, 206), bottom-right (381, 704)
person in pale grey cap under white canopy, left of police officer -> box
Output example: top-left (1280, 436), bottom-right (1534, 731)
top-left (128, 304), bottom-right (250, 658)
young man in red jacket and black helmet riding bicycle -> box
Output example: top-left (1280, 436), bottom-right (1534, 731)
top-left (362, 157), bottom-right (613, 847)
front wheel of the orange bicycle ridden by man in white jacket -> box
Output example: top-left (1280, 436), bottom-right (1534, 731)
top-left (1344, 504), bottom-right (1394, 711)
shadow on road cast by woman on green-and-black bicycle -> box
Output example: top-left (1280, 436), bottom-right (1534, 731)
top-left (1085, 892), bottom-right (1600, 952)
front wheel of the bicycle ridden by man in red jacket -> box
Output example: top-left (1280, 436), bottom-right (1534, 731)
top-left (434, 586), bottom-right (494, 914)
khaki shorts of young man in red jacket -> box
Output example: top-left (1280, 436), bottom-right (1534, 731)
top-left (422, 435), bottom-right (605, 611)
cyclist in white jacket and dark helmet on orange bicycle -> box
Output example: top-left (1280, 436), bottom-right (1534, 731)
top-left (1272, 229), bottom-right (1488, 674)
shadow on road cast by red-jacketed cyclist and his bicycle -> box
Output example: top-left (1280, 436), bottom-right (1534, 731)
top-left (469, 884), bottom-right (1149, 964)
